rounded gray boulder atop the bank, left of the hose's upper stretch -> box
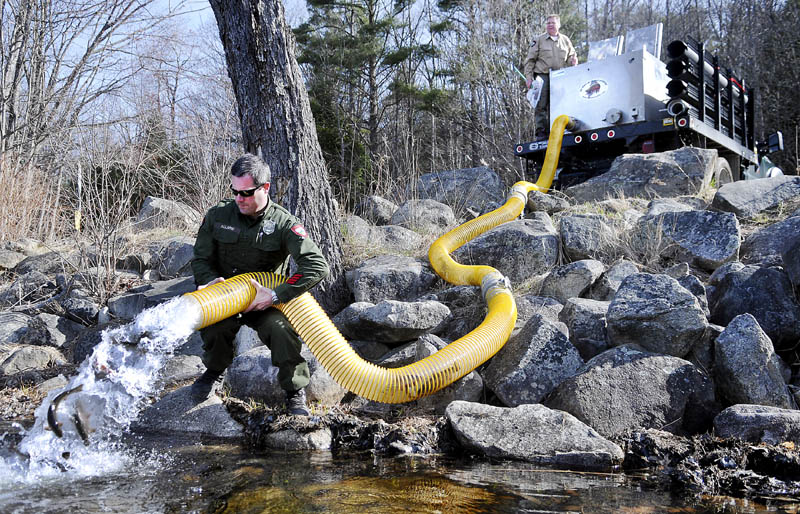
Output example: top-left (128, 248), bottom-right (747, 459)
top-left (409, 166), bottom-right (507, 217)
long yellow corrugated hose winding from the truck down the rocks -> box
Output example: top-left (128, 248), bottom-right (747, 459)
top-left (184, 116), bottom-right (572, 403)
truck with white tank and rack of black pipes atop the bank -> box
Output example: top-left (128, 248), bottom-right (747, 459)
top-left (514, 23), bottom-right (783, 189)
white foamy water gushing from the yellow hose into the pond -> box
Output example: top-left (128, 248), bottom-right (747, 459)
top-left (0, 297), bottom-right (201, 486)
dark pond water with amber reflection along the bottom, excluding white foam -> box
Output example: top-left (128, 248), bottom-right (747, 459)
top-left (0, 426), bottom-right (800, 514)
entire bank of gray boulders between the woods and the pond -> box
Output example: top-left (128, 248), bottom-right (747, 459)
top-left (0, 149), bottom-right (800, 500)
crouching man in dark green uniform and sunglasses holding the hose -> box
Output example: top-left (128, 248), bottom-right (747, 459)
top-left (191, 154), bottom-right (328, 416)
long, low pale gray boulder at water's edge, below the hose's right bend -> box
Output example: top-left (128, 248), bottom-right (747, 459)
top-left (445, 401), bottom-right (624, 470)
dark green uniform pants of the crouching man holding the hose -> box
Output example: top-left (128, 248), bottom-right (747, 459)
top-left (200, 308), bottom-right (311, 391)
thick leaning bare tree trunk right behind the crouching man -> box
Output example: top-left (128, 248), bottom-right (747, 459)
top-left (209, 0), bottom-right (347, 311)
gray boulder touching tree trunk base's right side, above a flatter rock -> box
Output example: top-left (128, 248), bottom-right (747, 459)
top-left (345, 255), bottom-right (436, 303)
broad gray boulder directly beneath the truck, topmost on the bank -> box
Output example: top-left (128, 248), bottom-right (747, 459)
top-left (566, 146), bottom-right (719, 203)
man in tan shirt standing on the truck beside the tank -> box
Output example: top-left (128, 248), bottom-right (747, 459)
top-left (525, 14), bottom-right (578, 139)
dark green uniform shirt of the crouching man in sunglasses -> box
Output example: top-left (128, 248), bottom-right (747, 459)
top-left (192, 200), bottom-right (328, 303)
